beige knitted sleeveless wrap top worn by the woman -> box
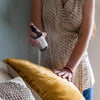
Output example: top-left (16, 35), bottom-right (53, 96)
top-left (40, 0), bottom-right (94, 92)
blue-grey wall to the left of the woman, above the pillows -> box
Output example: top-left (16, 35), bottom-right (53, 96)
top-left (0, 0), bottom-right (37, 60)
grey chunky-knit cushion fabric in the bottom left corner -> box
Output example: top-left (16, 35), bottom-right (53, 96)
top-left (0, 77), bottom-right (35, 100)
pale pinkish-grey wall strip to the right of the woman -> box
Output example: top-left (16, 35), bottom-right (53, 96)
top-left (88, 0), bottom-right (100, 100)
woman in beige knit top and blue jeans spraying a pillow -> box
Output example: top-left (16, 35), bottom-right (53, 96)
top-left (29, 0), bottom-right (95, 100)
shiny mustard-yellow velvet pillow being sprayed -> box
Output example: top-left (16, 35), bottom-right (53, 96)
top-left (3, 58), bottom-right (85, 100)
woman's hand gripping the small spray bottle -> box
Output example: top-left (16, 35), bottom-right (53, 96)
top-left (28, 24), bottom-right (47, 48)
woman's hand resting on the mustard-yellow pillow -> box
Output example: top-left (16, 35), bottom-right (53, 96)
top-left (51, 68), bottom-right (73, 81)
